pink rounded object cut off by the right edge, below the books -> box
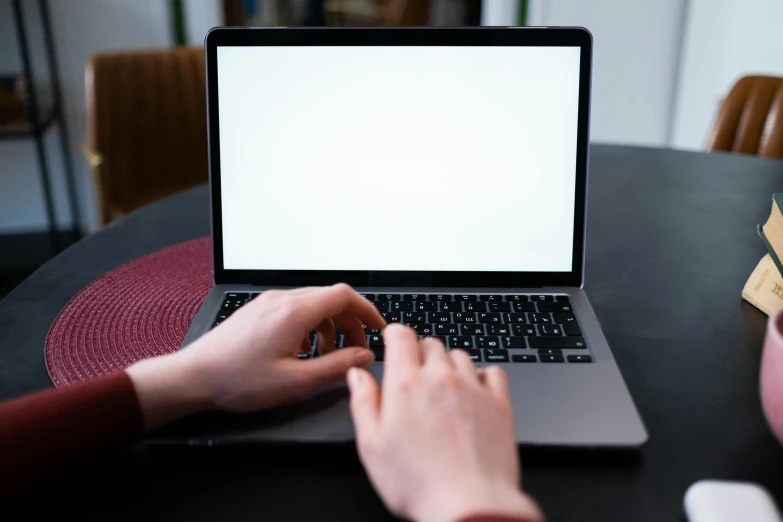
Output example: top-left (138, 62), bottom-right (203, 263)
top-left (759, 308), bottom-right (783, 444)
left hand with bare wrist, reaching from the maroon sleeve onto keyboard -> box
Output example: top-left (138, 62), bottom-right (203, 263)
top-left (127, 284), bottom-right (386, 429)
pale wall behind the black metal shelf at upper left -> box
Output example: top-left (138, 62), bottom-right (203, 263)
top-left (0, 0), bottom-right (222, 233)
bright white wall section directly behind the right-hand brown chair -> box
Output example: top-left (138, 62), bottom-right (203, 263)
top-left (672, 0), bottom-right (783, 149)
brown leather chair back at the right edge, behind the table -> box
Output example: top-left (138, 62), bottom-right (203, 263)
top-left (706, 76), bottom-right (783, 159)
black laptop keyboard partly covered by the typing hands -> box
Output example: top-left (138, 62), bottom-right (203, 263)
top-left (212, 292), bottom-right (593, 363)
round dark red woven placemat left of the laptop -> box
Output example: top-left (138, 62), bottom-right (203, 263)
top-left (44, 237), bottom-right (212, 386)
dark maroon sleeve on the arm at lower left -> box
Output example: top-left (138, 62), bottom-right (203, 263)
top-left (0, 371), bottom-right (143, 498)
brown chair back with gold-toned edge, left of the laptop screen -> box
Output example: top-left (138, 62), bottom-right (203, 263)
top-left (85, 49), bottom-right (208, 224)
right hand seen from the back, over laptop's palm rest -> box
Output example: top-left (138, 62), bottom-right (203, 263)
top-left (348, 325), bottom-right (541, 522)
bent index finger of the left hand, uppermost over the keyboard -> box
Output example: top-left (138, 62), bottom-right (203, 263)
top-left (293, 283), bottom-right (386, 329)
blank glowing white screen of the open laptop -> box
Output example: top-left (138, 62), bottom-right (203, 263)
top-left (217, 47), bottom-right (580, 272)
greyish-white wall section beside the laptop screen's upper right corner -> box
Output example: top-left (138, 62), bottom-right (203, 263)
top-left (528, 0), bottom-right (688, 146)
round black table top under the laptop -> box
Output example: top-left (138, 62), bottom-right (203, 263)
top-left (0, 145), bottom-right (783, 522)
